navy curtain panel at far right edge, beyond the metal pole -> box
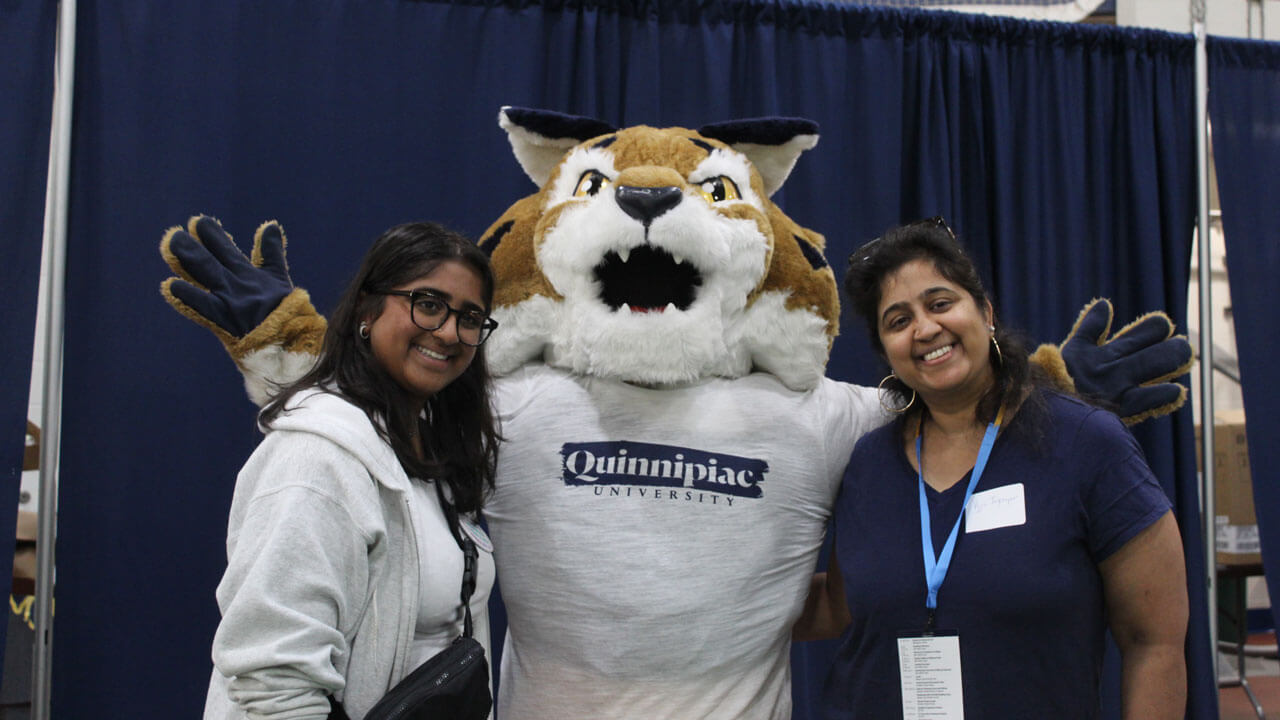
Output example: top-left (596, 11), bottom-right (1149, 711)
top-left (1208, 37), bottom-right (1280, 628)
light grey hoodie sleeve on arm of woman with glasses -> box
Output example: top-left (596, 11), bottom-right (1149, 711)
top-left (212, 433), bottom-right (372, 717)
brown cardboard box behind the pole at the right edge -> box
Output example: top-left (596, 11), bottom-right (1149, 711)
top-left (1196, 410), bottom-right (1262, 565)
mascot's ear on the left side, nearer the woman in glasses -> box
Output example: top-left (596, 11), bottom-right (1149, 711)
top-left (498, 105), bottom-right (617, 187)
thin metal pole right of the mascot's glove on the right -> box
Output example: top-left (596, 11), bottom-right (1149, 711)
top-left (1192, 0), bottom-right (1217, 703)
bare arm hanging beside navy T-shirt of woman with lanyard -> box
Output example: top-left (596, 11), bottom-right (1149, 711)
top-left (1098, 511), bottom-right (1188, 720)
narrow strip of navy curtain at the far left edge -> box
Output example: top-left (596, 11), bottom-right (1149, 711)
top-left (0, 0), bottom-right (58, 657)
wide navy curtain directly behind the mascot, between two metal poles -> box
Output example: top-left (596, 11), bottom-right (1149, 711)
top-left (54, 0), bottom-right (1216, 719)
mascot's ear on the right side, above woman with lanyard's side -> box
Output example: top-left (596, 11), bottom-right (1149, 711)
top-left (698, 118), bottom-right (818, 196)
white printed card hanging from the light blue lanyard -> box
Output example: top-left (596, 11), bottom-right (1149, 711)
top-left (897, 635), bottom-right (964, 720)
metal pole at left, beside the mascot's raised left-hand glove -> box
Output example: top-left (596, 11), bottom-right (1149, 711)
top-left (31, 0), bottom-right (76, 720)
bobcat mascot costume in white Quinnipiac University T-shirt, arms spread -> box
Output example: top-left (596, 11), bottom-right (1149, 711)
top-left (161, 108), bottom-right (1190, 720)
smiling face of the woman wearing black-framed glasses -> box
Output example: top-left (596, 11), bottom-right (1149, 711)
top-left (365, 260), bottom-right (488, 404)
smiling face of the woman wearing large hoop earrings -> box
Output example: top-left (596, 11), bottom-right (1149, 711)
top-left (877, 260), bottom-right (995, 406)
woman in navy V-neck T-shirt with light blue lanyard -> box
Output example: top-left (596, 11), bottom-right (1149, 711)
top-left (795, 220), bottom-right (1188, 720)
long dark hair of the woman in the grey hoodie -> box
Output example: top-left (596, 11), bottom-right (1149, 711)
top-left (259, 223), bottom-right (500, 512)
